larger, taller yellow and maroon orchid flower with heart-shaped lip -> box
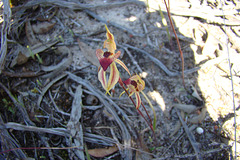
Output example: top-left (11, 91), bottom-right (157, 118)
top-left (96, 25), bottom-right (131, 95)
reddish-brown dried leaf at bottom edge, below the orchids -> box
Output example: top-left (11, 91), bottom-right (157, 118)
top-left (88, 146), bottom-right (118, 158)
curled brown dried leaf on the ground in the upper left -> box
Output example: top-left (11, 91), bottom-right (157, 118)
top-left (32, 22), bottom-right (56, 34)
